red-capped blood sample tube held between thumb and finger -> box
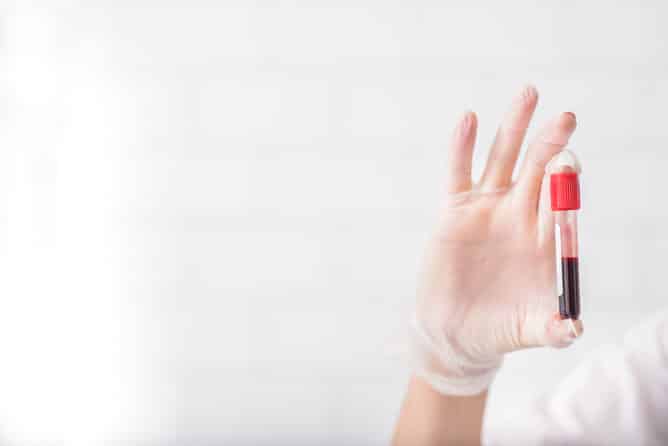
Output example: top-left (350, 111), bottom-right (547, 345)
top-left (547, 150), bottom-right (581, 325)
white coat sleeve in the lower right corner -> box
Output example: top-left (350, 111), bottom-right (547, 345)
top-left (483, 312), bottom-right (668, 446)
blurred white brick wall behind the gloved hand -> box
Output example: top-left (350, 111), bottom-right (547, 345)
top-left (0, 0), bottom-right (668, 446)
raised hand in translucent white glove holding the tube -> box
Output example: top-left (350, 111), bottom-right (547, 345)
top-left (413, 87), bottom-right (582, 395)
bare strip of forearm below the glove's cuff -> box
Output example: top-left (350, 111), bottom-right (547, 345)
top-left (392, 376), bottom-right (487, 446)
